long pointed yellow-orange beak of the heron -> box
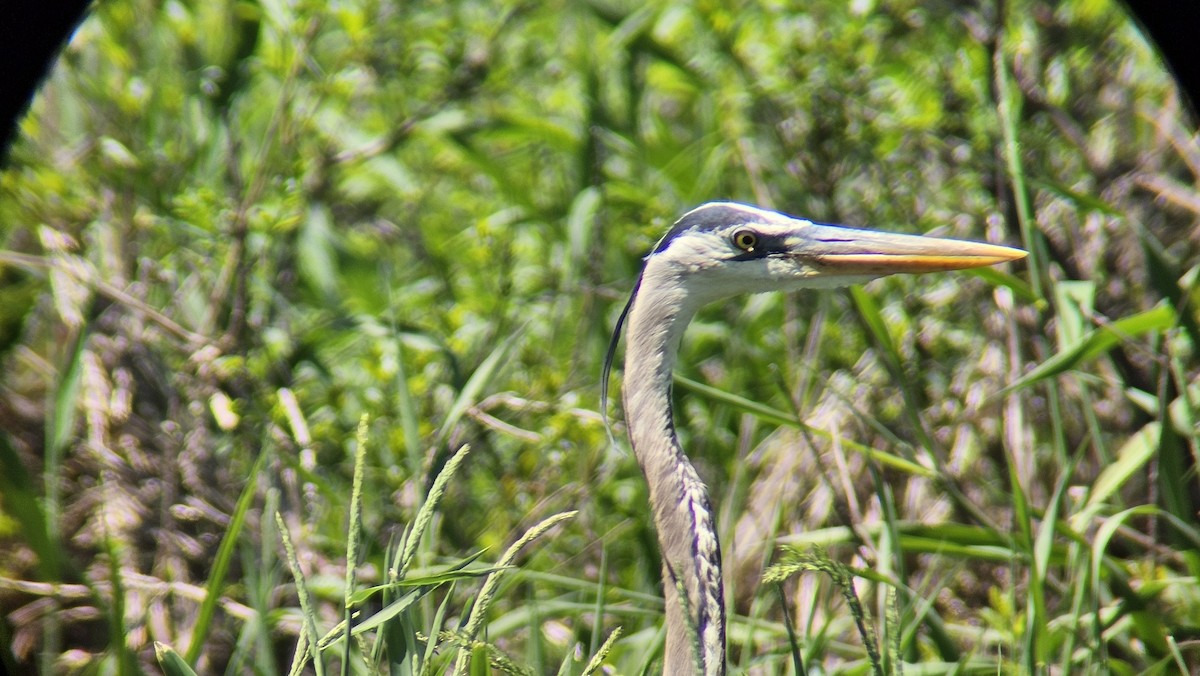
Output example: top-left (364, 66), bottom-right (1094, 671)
top-left (794, 223), bottom-right (1027, 275)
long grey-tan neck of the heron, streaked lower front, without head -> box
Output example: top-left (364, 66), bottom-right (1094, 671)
top-left (624, 268), bottom-right (725, 676)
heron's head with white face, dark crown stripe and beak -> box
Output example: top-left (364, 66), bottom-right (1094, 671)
top-left (643, 202), bottom-right (1026, 303)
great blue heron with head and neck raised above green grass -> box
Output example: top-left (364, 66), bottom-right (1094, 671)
top-left (601, 202), bottom-right (1025, 676)
